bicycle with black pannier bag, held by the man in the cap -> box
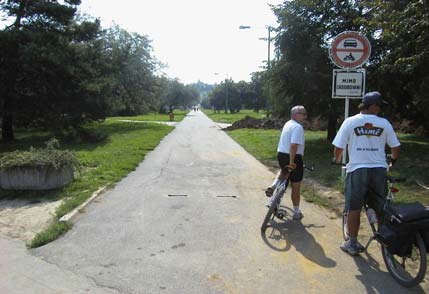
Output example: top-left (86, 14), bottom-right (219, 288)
top-left (342, 176), bottom-right (429, 287)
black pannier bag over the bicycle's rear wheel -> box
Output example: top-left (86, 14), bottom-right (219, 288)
top-left (378, 202), bottom-right (429, 256)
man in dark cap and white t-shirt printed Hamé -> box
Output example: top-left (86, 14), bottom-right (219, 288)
top-left (332, 92), bottom-right (400, 256)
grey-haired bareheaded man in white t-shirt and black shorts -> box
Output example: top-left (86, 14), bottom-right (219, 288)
top-left (265, 105), bottom-right (307, 220)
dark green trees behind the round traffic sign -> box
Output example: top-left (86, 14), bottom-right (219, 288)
top-left (266, 0), bottom-right (429, 137)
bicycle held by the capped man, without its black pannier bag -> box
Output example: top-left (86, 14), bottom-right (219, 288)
top-left (342, 172), bottom-right (427, 287)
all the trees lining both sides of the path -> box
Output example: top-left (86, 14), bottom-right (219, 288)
top-left (0, 0), bottom-right (429, 141)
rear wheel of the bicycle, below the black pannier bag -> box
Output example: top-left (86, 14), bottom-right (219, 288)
top-left (381, 232), bottom-right (427, 287)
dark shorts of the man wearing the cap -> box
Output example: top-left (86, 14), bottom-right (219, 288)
top-left (344, 167), bottom-right (387, 215)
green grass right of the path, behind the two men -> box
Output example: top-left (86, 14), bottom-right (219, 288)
top-left (228, 129), bottom-right (429, 205)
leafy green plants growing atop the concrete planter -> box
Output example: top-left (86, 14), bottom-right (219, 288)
top-left (0, 138), bottom-right (80, 170)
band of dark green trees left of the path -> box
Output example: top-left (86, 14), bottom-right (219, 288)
top-left (0, 0), bottom-right (199, 141)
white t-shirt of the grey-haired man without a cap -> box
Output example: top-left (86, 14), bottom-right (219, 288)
top-left (277, 119), bottom-right (305, 155)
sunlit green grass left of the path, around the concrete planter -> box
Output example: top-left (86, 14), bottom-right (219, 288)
top-left (0, 119), bottom-right (173, 247)
